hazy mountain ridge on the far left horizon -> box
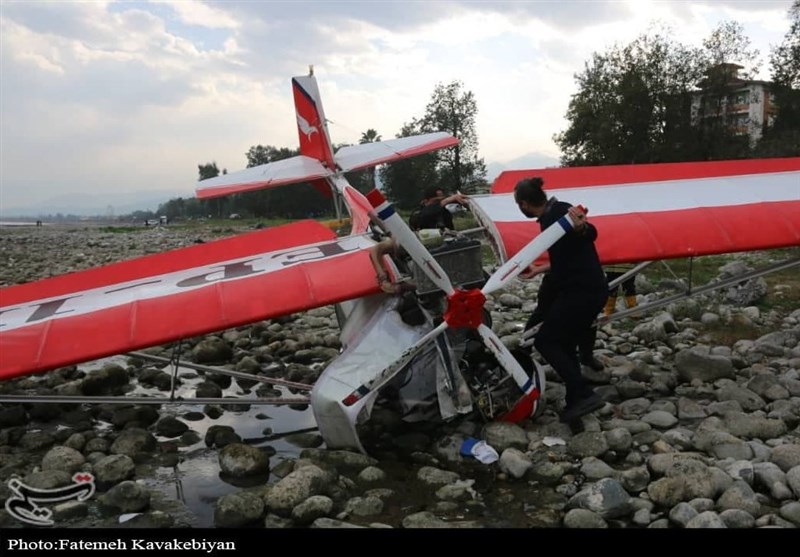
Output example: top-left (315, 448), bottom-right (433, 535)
top-left (0, 190), bottom-right (194, 218)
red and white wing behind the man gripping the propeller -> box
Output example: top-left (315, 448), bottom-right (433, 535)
top-left (472, 158), bottom-right (800, 264)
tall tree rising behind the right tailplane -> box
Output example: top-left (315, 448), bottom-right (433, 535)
top-left (420, 81), bottom-right (488, 193)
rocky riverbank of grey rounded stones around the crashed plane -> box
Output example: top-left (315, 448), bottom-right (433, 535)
top-left (0, 222), bottom-right (800, 528)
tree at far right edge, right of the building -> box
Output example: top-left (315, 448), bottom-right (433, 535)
top-left (758, 0), bottom-right (800, 157)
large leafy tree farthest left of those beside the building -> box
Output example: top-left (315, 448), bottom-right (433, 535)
top-left (554, 29), bottom-right (703, 166)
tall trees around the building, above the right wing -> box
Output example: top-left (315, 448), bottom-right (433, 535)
top-left (553, 5), bottom-right (800, 166)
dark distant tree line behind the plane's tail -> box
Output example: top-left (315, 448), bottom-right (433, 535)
top-left (158, 81), bottom-right (489, 220)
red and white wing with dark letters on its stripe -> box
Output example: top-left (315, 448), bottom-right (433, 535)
top-left (0, 221), bottom-right (380, 380)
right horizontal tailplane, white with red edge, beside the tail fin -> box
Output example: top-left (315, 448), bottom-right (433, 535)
top-left (334, 132), bottom-right (458, 172)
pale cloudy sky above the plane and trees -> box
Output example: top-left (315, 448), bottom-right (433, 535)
top-left (0, 0), bottom-right (792, 216)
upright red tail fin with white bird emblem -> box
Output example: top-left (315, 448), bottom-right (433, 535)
top-left (292, 74), bottom-right (336, 171)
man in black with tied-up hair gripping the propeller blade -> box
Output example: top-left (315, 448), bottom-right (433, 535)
top-left (514, 177), bottom-right (608, 423)
